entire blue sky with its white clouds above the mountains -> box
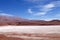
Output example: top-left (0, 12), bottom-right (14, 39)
top-left (0, 0), bottom-right (60, 20)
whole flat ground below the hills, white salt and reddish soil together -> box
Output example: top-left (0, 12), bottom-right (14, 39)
top-left (0, 25), bottom-right (60, 40)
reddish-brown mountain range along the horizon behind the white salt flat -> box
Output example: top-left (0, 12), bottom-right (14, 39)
top-left (0, 16), bottom-right (60, 25)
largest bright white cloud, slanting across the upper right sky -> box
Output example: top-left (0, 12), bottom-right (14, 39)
top-left (34, 4), bottom-right (55, 16)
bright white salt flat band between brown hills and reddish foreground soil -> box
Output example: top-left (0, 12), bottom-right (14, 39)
top-left (0, 26), bottom-right (60, 33)
